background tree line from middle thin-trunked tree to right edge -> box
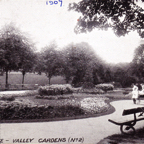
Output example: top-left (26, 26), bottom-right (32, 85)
top-left (38, 42), bottom-right (144, 87)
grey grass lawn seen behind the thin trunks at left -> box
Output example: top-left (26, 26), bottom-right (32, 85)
top-left (0, 72), bottom-right (65, 91)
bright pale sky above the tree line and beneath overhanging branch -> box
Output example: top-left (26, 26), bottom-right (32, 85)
top-left (0, 0), bottom-right (143, 63)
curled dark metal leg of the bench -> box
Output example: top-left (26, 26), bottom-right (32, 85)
top-left (120, 125), bottom-right (135, 135)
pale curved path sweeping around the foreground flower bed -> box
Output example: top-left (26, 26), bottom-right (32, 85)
top-left (0, 100), bottom-right (144, 144)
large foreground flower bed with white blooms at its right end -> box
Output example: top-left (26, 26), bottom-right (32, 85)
top-left (0, 97), bottom-right (108, 120)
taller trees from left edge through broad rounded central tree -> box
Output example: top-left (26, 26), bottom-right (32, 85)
top-left (0, 25), bottom-right (111, 87)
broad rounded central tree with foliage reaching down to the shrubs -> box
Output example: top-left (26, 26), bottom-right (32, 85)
top-left (63, 42), bottom-right (102, 86)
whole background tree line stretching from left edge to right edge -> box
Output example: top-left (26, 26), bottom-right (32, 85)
top-left (0, 25), bottom-right (144, 87)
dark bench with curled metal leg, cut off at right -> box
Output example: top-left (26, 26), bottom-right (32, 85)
top-left (108, 107), bottom-right (144, 135)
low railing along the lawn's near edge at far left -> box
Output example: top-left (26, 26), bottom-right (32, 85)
top-left (0, 84), bottom-right (39, 91)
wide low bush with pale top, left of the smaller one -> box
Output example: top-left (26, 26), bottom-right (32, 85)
top-left (38, 84), bottom-right (73, 96)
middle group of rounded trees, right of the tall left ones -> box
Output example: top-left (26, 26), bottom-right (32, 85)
top-left (35, 42), bottom-right (109, 86)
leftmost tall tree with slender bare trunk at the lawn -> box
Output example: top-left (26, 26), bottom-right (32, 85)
top-left (0, 25), bottom-right (21, 88)
